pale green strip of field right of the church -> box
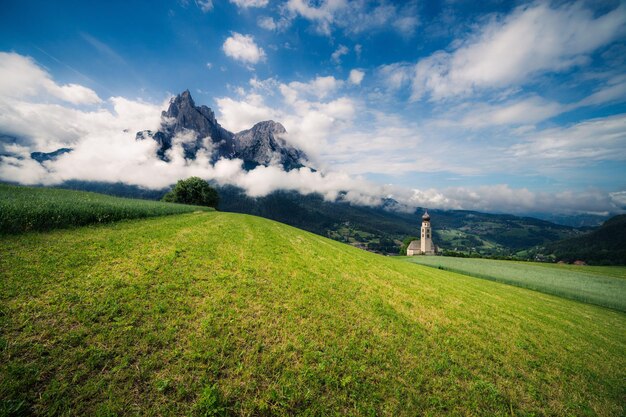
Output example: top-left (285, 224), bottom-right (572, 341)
top-left (401, 256), bottom-right (626, 312)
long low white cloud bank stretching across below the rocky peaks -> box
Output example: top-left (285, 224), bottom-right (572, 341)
top-left (0, 53), bottom-right (626, 213)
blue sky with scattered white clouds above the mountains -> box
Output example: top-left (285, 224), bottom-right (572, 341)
top-left (0, 0), bottom-right (626, 213)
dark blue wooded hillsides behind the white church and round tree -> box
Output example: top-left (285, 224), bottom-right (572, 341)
top-left (41, 181), bottom-right (581, 255)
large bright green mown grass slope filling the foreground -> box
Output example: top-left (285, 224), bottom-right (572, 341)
top-left (0, 212), bottom-right (626, 416)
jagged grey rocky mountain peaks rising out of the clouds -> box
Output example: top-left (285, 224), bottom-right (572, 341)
top-left (136, 90), bottom-right (306, 170)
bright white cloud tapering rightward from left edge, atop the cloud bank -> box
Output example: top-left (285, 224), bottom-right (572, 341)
top-left (0, 52), bottom-right (102, 105)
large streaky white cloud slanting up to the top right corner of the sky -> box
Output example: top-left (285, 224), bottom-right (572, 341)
top-left (413, 2), bottom-right (626, 100)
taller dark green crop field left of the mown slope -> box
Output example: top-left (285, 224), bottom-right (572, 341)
top-left (0, 183), bottom-right (211, 234)
